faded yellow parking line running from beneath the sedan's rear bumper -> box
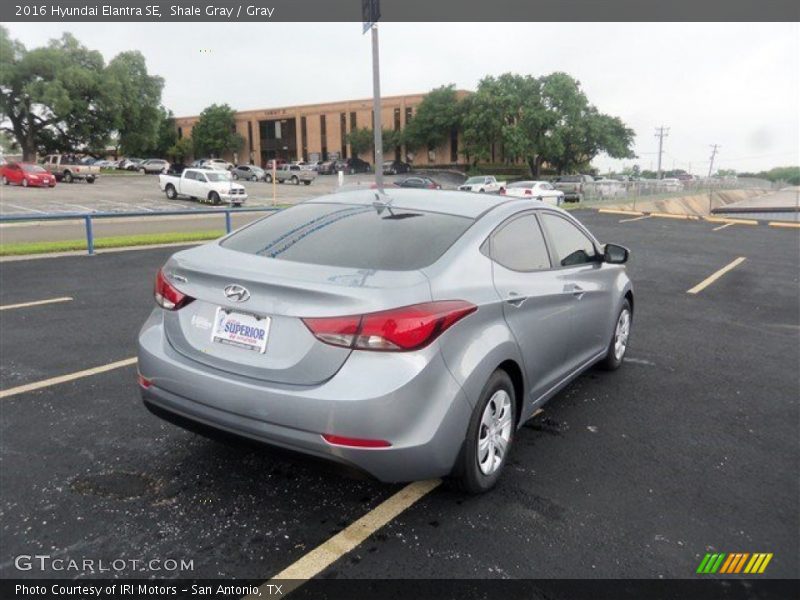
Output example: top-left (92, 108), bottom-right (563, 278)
top-left (247, 479), bottom-right (442, 599)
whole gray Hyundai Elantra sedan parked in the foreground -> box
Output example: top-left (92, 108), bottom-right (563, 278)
top-left (139, 189), bottom-right (633, 492)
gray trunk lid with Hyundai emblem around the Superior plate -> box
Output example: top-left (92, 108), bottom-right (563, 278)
top-left (159, 243), bottom-right (431, 385)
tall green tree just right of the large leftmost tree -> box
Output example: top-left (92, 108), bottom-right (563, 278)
top-left (106, 51), bottom-right (165, 156)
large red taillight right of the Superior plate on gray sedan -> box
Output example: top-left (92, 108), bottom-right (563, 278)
top-left (303, 300), bottom-right (478, 352)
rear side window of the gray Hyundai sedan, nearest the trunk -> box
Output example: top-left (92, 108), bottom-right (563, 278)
top-left (490, 215), bottom-right (550, 271)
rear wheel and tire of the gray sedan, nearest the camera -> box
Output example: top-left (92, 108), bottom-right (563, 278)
top-left (452, 369), bottom-right (517, 494)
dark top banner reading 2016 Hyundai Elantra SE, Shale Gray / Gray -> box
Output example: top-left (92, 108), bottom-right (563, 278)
top-left (0, 0), bottom-right (800, 23)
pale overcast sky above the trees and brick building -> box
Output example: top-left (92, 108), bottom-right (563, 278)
top-left (7, 23), bottom-right (800, 174)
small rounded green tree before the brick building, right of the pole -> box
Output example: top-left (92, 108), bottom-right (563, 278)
top-left (403, 85), bottom-right (461, 150)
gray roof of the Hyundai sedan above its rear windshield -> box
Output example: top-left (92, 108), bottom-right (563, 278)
top-left (307, 187), bottom-right (516, 219)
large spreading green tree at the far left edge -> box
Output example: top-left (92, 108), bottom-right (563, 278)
top-left (0, 27), bottom-right (119, 160)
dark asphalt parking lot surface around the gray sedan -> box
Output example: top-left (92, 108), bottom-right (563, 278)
top-left (0, 210), bottom-right (800, 581)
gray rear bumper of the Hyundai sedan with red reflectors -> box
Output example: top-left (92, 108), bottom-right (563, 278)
top-left (139, 309), bottom-right (471, 481)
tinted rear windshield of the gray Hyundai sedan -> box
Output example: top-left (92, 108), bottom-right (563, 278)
top-left (221, 204), bottom-right (473, 271)
